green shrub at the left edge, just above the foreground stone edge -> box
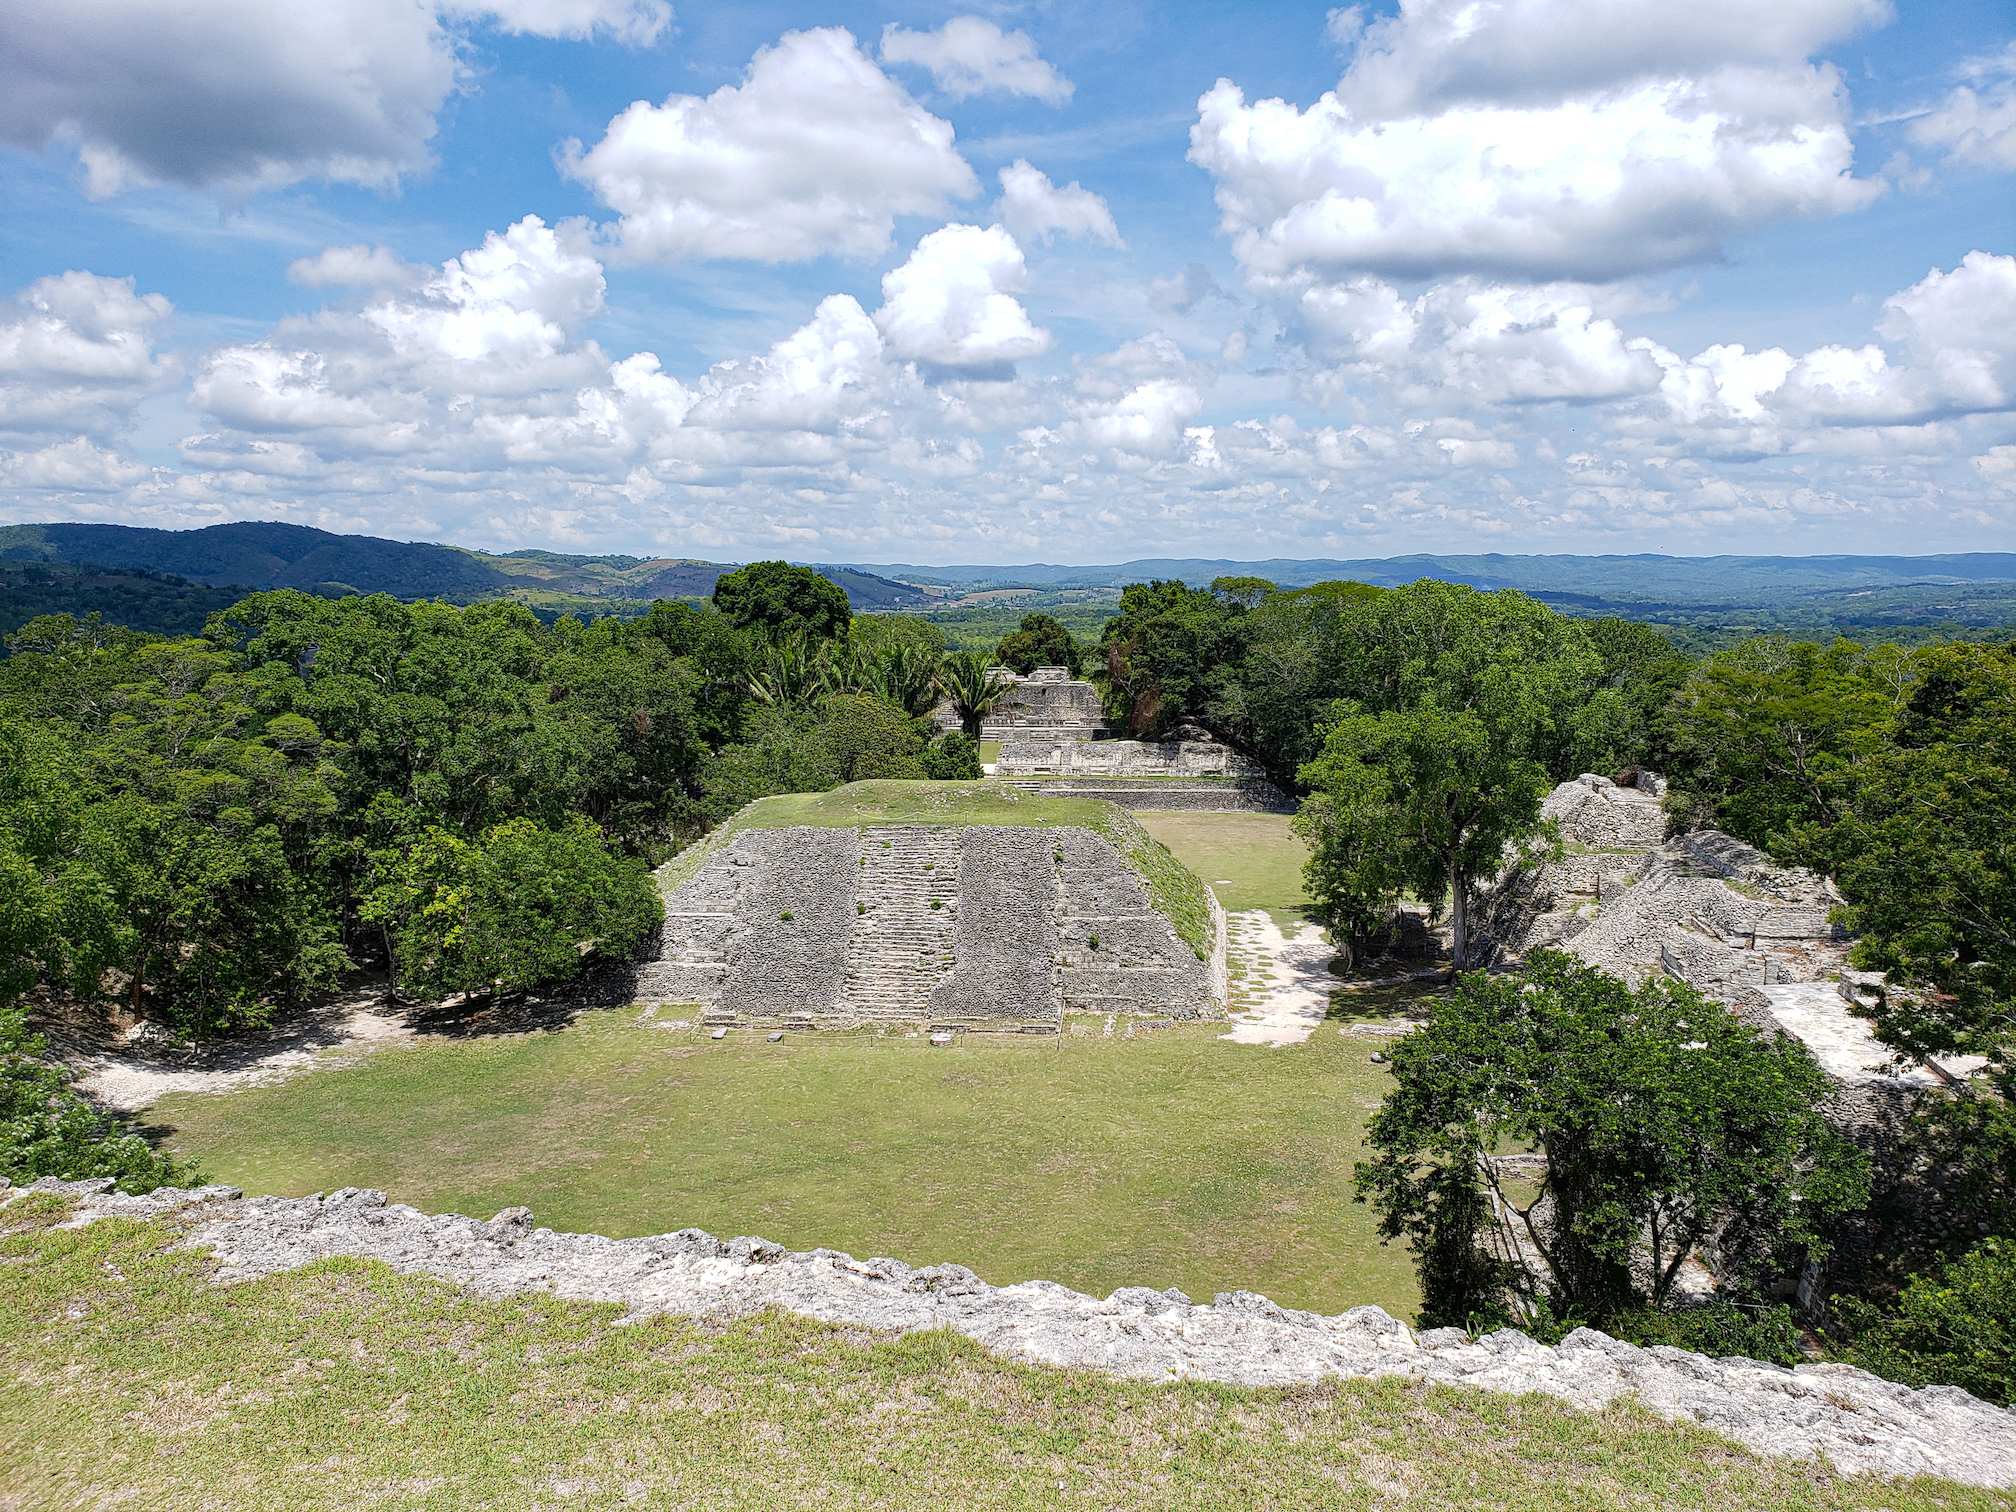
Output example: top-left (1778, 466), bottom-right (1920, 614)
top-left (0, 1008), bottom-right (196, 1191)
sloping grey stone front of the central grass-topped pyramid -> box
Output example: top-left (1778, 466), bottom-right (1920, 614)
top-left (637, 818), bottom-right (1226, 1032)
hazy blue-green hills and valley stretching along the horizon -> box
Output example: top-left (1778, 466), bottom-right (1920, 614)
top-left (0, 520), bottom-right (2016, 651)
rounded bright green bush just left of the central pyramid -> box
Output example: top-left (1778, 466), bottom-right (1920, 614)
top-left (363, 818), bottom-right (665, 996)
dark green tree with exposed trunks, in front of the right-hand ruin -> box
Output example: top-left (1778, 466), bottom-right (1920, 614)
top-left (1357, 952), bottom-right (1867, 1327)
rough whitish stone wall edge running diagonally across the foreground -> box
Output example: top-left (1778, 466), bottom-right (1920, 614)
top-left (32, 1181), bottom-right (2016, 1488)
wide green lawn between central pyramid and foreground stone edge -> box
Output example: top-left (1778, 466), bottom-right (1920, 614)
top-left (145, 1008), bottom-right (1417, 1316)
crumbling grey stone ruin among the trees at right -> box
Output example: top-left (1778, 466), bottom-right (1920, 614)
top-left (1478, 772), bottom-right (1980, 1129)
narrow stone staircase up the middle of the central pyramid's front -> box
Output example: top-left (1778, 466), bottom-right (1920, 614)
top-left (847, 825), bottom-right (960, 1020)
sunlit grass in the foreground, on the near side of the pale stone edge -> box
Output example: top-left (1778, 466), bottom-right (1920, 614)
top-left (0, 1198), bottom-right (2010, 1512)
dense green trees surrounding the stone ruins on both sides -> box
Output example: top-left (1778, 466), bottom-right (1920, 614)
top-left (0, 562), bottom-right (2016, 1395)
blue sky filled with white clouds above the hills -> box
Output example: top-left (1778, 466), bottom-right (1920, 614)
top-left (0, 0), bottom-right (2016, 562)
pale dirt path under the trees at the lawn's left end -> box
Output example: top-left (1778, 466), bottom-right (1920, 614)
top-left (69, 994), bottom-right (415, 1113)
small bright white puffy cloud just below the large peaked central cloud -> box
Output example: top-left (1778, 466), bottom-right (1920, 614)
top-left (875, 226), bottom-right (1050, 375)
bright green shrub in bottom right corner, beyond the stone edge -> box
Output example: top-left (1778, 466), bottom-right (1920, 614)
top-left (1835, 1240), bottom-right (2016, 1407)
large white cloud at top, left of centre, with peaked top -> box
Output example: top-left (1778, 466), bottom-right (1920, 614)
top-left (564, 26), bottom-right (980, 262)
